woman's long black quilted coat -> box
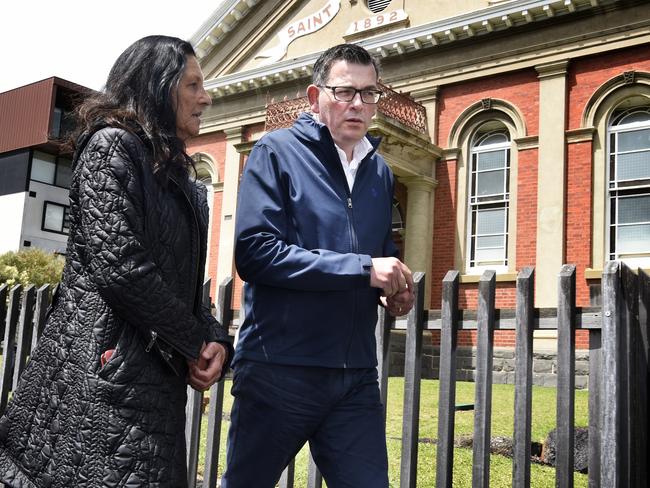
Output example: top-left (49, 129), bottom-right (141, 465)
top-left (0, 128), bottom-right (232, 488)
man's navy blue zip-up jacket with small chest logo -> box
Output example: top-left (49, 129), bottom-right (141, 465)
top-left (234, 114), bottom-right (397, 368)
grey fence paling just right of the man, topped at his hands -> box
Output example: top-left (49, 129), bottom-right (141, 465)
top-left (400, 271), bottom-right (424, 488)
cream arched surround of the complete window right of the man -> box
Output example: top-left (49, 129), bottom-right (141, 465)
top-left (447, 99), bottom-right (527, 275)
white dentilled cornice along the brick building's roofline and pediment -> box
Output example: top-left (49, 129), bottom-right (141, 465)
top-left (201, 0), bottom-right (620, 98)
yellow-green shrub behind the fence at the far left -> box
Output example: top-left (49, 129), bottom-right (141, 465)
top-left (0, 249), bottom-right (65, 287)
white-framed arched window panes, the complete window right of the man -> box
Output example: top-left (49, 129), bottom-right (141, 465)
top-left (467, 125), bottom-right (511, 271)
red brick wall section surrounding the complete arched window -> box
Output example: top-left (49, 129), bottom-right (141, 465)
top-left (431, 70), bottom-right (539, 346)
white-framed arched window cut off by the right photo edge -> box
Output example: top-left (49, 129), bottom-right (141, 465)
top-left (607, 106), bottom-right (650, 267)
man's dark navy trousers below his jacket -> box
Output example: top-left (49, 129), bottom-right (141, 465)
top-left (221, 361), bottom-right (388, 488)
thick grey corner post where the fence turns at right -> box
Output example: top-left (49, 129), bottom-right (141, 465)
top-left (600, 261), bottom-right (629, 488)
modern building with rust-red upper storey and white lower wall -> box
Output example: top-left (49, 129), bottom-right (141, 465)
top-left (0, 77), bottom-right (89, 253)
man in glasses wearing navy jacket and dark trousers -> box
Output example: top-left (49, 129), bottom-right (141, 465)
top-left (222, 44), bottom-right (413, 488)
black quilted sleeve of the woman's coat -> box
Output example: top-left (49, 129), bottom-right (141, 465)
top-left (76, 129), bottom-right (207, 359)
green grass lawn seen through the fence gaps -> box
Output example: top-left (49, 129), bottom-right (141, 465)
top-left (194, 378), bottom-right (588, 488)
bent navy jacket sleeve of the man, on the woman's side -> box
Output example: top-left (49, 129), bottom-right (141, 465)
top-left (235, 144), bottom-right (372, 291)
